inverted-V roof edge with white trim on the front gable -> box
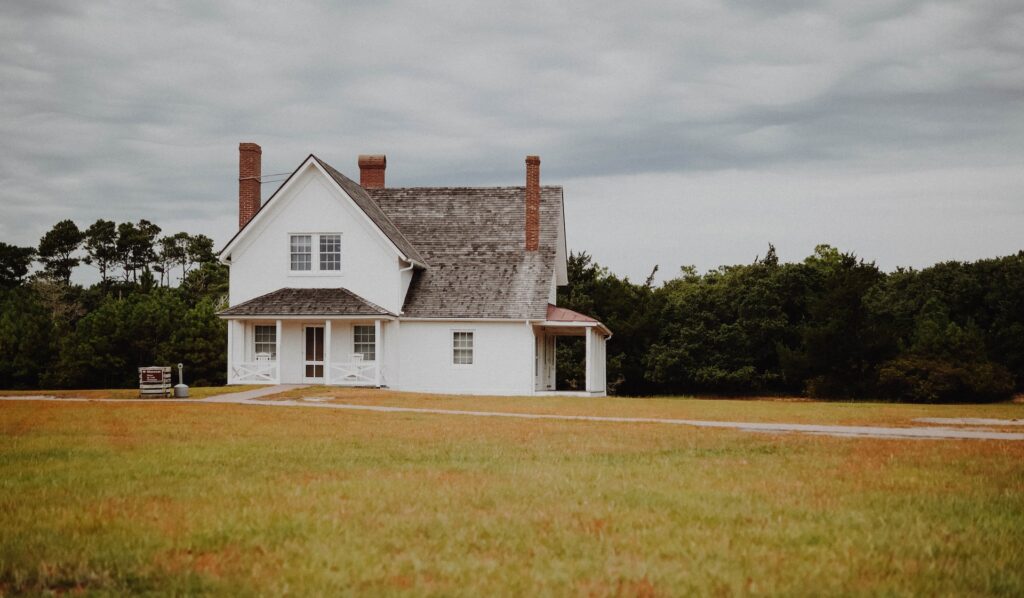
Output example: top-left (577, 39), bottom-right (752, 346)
top-left (218, 154), bottom-right (427, 267)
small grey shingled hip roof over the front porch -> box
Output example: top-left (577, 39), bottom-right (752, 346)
top-left (218, 288), bottom-right (394, 317)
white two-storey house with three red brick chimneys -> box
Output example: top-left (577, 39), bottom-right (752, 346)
top-left (220, 143), bottom-right (610, 396)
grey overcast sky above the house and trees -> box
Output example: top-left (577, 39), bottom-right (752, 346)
top-left (0, 0), bottom-right (1024, 279)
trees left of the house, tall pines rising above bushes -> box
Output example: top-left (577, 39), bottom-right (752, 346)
top-left (0, 219), bottom-right (227, 388)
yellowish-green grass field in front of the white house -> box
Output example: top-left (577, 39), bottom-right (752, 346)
top-left (0, 391), bottom-right (1024, 596)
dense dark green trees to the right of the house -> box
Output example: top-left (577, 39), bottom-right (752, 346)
top-left (558, 245), bottom-right (1024, 402)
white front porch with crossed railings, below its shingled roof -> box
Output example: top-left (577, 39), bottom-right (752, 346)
top-left (227, 317), bottom-right (387, 387)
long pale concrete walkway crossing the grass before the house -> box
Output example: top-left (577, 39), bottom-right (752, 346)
top-left (0, 385), bottom-right (1024, 440)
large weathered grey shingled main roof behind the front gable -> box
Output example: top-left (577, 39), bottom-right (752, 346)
top-left (367, 186), bottom-right (562, 319)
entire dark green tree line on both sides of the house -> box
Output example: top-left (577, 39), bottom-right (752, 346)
top-left (0, 220), bottom-right (1024, 401)
